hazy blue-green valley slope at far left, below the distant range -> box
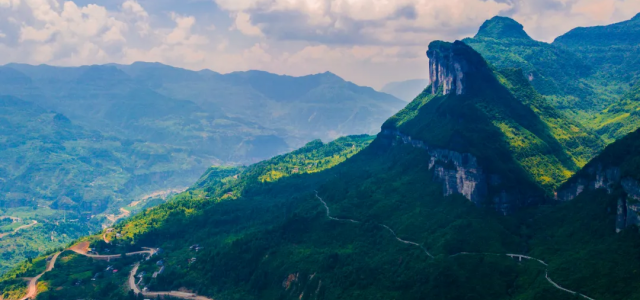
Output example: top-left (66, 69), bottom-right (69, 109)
top-left (0, 96), bottom-right (203, 272)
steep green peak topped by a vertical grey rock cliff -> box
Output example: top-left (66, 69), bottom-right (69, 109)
top-left (382, 42), bottom-right (603, 199)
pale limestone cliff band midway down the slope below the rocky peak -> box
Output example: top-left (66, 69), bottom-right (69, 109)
top-left (382, 129), bottom-right (520, 214)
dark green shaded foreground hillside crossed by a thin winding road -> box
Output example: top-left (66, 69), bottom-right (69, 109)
top-left (13, 121), bottom-right (640, 300)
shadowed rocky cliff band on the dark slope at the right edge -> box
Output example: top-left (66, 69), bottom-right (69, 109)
top-left (556, 164), bottom-right (640, 232)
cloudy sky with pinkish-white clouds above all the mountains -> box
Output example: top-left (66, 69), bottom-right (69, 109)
top-left (0, 0), bottom-right (640, 88)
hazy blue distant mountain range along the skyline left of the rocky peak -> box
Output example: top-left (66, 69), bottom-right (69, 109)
top-left (0, 63), bottom-right (405, 162)
